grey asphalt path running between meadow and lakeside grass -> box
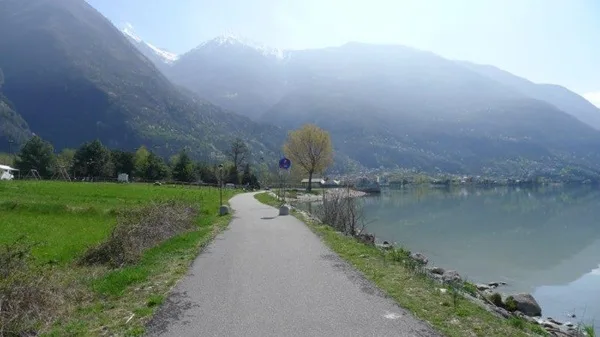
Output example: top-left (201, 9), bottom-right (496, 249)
top-left (148, 194), bottom-right (440, 337)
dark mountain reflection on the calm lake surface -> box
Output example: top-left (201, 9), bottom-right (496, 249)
top-left (364, 187), bottom-right (600, 291)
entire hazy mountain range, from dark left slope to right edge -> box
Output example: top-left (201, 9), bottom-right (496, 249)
top-left (0, 0), bottom-right (600, 178)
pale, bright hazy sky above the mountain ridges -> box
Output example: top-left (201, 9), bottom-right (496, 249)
top-left (88, 0), bottom-right (600, 105)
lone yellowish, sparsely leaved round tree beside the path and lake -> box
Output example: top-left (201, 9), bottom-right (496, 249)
top-left (283, 124), bottom-right (333, 191)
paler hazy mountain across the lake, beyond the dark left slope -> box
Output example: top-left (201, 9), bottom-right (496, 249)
top-left (123, 30), bottom-right (600, 173)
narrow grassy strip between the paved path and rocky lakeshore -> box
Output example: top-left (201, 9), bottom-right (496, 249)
top-left (255, 193), bottom-right (546, 337)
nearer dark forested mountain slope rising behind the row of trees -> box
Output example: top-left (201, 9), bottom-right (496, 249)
top-left (0, 0), bottom-right (285, 156)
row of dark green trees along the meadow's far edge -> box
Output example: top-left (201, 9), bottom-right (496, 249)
top-left (7, 136), bottom-right (258, 187)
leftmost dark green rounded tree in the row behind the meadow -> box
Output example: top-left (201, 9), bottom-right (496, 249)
top-left (15, 136), bottom-right (56, 178)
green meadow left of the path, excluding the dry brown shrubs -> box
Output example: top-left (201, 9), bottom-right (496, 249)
top-left (0, 181), bottom-right (233, 336)
